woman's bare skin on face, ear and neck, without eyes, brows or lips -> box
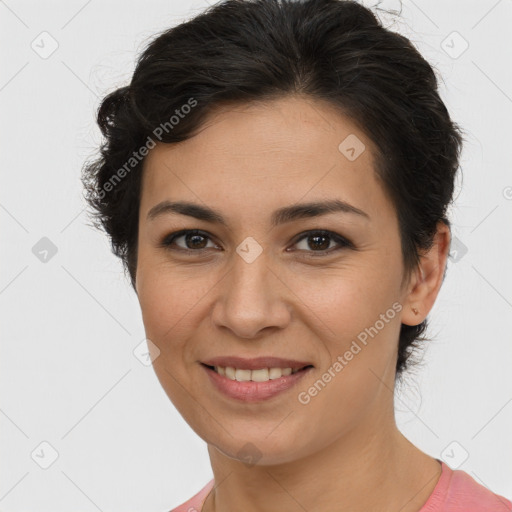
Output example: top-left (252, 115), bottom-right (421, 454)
top-left (136, 96), bottom-right (450, 512)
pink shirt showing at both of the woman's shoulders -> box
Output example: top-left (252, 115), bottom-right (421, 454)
top-left (171, 461), bottom-right (512, 512)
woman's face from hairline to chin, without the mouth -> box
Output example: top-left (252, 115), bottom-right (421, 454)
top-left (136, 97), bottom-right (416, 464)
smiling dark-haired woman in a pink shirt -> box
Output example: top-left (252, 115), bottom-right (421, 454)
top-left (84, 0), bottom-right (512, 512)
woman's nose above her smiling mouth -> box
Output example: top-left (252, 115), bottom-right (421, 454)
top-left (212, 252), bottom-right (293, 339)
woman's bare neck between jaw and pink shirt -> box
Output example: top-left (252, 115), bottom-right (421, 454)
top-left (202, 419), bottom-right (441, 512)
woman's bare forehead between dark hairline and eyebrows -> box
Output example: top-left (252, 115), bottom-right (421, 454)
top-left (141, 97), bottom-right (391, 228)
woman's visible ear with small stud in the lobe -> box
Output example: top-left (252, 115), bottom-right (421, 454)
top-left (401, 221), bottom-right (451, 325)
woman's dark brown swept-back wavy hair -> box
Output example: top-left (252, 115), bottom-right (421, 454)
top-left (82, 0), bottom-right (463, 377)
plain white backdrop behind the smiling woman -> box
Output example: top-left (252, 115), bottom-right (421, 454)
top-left (0, 0), bottom-right (512, 512)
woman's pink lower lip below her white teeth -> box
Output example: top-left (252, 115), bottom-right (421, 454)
top-left (201, 363), bottom-right (313, 402)
